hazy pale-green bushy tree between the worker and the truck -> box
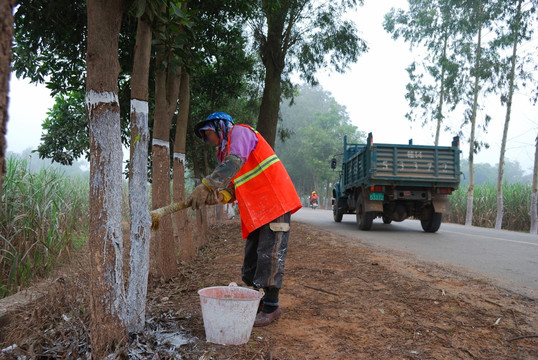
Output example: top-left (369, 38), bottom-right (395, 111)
top-left (275, 85), bottom-right (365, 202)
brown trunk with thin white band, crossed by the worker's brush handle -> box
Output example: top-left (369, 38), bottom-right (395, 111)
top-left (151, 7), bottom-right (181, 280)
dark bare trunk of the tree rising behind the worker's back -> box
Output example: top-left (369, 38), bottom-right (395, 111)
top-left (257, 1), bottom-right (287, 148)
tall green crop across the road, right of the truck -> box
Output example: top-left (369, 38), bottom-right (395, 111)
top-left (445, 183), bottom-right (531, 232)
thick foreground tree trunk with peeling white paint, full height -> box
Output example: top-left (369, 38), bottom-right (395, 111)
top-left (86, 0), bottom-right (127, 359)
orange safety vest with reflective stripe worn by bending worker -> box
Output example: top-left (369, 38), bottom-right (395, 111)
top-left (226, 124), bottom-right (302, 239)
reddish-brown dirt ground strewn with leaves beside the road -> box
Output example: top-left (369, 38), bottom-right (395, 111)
top-left (0, 219), bottom-right (538, 360)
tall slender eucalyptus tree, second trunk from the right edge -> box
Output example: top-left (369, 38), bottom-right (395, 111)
top-left (493, 0), bottom-right (538, 229)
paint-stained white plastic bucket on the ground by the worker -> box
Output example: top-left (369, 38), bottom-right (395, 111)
top-left (198, 283), bottom-right (262, 345)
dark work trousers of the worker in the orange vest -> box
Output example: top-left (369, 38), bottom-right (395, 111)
top-left (242, 212), bottom-right (291, 306)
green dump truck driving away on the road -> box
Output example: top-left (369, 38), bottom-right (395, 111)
top-left (331, 133), bottom-right (461, 232)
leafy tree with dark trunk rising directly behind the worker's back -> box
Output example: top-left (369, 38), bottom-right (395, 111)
top-left (252, 0), bottom-right (367, 146)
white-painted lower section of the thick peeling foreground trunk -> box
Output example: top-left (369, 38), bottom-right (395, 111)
top-left (86, 90), bottom-right (125, 338)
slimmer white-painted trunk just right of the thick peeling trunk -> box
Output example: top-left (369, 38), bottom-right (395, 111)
top-left (127, 12), bottom-right (151, 332)
